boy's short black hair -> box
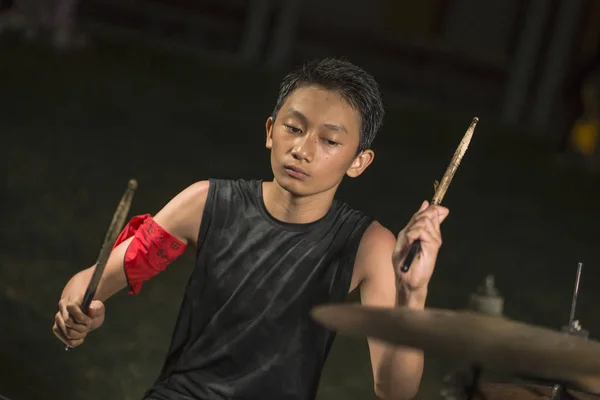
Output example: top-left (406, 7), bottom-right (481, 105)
top-left (272, 58), bottom-right (385, 152)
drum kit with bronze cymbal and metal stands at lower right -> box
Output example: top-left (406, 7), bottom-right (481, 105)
top-left (312, 263), bottom-right (600, 400)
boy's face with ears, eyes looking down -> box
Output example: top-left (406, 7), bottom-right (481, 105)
top-left (266, 86), bottom-right (374, 196)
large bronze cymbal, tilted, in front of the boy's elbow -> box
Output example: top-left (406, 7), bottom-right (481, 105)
top-left (311, 304), bottom-right (600, 386)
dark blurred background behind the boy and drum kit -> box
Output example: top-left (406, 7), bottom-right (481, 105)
top-left (0, 0), bottom-right (600, 400)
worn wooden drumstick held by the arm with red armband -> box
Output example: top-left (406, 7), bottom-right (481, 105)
top-left (65, 179), bottom-right (137, 350)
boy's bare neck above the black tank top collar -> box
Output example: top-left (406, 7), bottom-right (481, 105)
top-left (262, 180), bottom-right (336, 224)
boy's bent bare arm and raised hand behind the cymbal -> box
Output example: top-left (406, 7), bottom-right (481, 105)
top-left (355, 201), bottom-right (450, 400)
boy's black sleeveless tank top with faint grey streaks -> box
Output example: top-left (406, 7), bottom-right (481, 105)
top-left (146, 180), bottom-right (372, 400)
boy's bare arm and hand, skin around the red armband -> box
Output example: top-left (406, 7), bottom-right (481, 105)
top-left (53, 181), bottom-right (209, 346)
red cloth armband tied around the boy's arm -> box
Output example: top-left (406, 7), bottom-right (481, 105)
top-left (113, 214), bottom-right (187, 295)
